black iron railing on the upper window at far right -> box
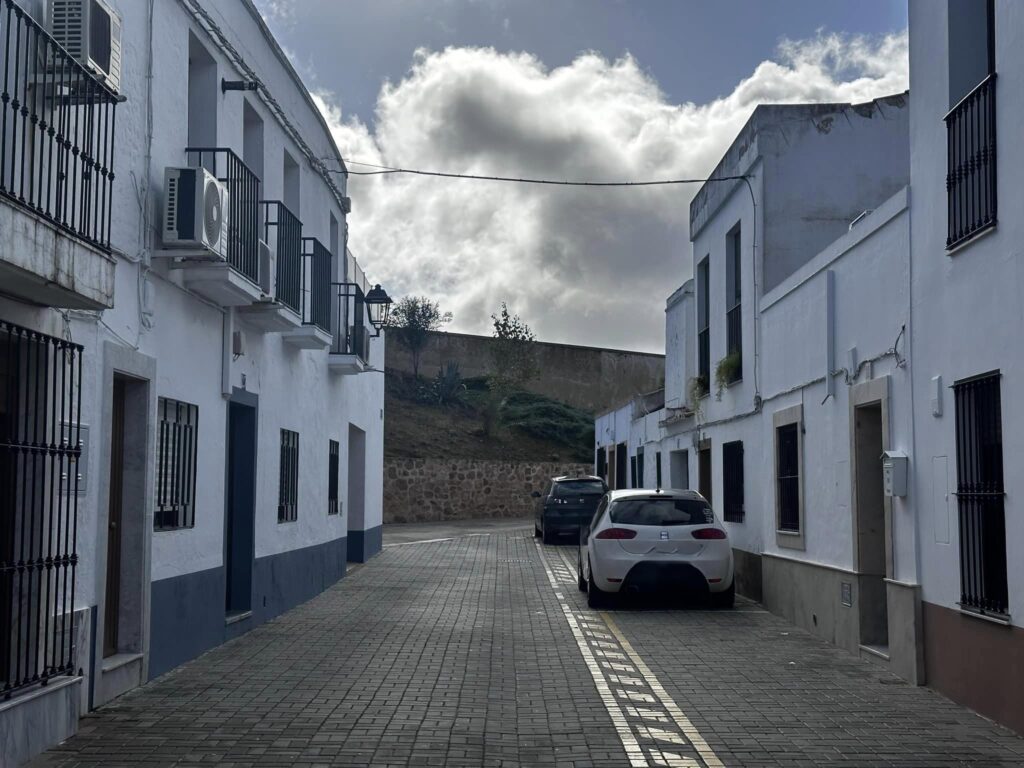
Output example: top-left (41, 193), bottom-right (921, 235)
top-left (945, 73), bottom-right (997, 249)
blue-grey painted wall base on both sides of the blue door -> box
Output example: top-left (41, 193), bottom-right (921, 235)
top-left (150, 537), bottom-right (348, 680)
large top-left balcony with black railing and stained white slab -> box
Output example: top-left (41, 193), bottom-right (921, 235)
top-left (0, 0), bottom-right (122, 309)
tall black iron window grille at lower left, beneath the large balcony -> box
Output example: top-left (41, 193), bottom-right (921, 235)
top-left (0, 319), bottom-right (82, 698)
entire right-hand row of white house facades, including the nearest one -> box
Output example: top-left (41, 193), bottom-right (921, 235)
top-left (596, 0), bottom-right (1024, 732)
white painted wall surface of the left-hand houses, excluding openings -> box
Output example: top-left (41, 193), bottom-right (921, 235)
top-left (0, 0), bottom-right (384, 606)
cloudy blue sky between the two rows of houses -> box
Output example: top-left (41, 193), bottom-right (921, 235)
top-left (257, 0), bottom-right (907, 350)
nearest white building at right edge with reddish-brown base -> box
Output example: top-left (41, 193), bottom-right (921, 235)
top-left (909, 0), bottom-right (1024, 732)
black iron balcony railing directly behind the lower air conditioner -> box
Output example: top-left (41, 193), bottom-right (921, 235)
top-left (185, 146), bottom-right (260, 285)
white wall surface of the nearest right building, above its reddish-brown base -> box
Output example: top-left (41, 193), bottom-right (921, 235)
top-left (909, 0), bottom-right (1024, 627)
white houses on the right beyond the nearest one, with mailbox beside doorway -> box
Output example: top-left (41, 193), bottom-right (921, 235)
top-left (596, 94), bottom-right (922, 680)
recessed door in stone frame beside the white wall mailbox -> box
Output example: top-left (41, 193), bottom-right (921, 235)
top-left (854, 402), bottom-right (889, 649)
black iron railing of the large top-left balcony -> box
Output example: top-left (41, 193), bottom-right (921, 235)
top-left (0, 0), bottom-right (120, 253)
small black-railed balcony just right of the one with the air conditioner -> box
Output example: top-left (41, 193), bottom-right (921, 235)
top-left (239, 201), bottom-right (302, 333)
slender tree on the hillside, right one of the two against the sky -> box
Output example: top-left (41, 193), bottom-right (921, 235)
top-left (483, 301), bottom-right (540, 434)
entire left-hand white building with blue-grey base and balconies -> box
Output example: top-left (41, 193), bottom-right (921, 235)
top-left (0, 0), bottom-right (384, 765)
